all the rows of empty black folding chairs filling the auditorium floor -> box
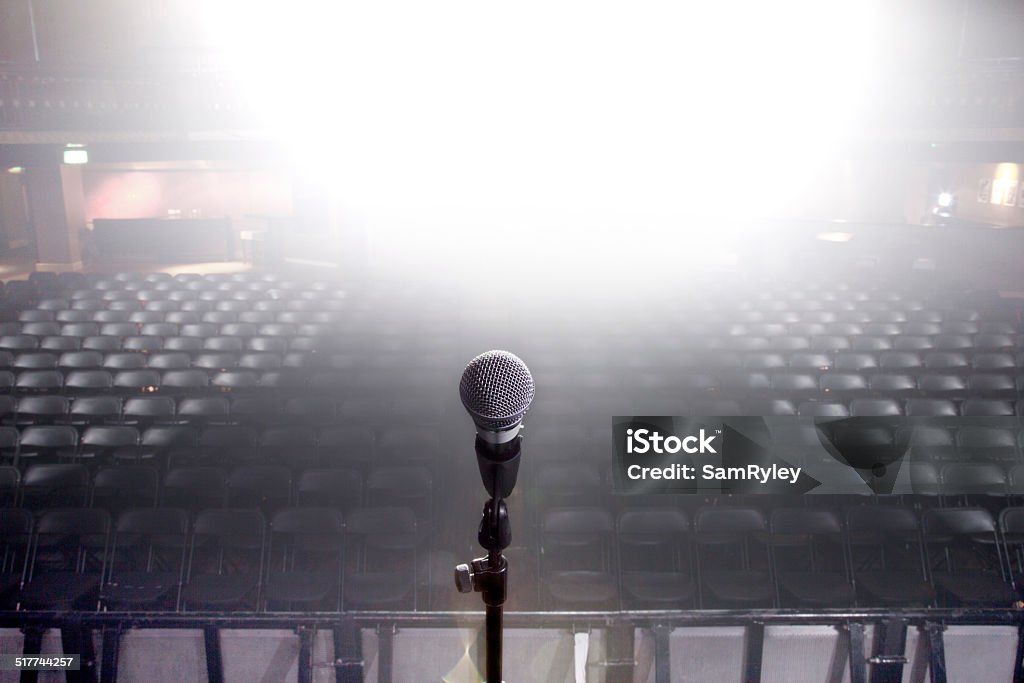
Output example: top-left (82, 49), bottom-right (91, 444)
top-left (0, 272), bottom-right (1024, 609)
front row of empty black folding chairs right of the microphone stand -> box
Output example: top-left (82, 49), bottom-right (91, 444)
top-left (540, 505), bottom-right (1024, 609)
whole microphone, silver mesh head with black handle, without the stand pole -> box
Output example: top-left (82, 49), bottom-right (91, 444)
top-left (459, 351), bottom-right (535, 498)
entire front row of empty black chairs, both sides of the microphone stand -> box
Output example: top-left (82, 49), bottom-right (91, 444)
top-left (0, 506), bottom-right (1024, 609)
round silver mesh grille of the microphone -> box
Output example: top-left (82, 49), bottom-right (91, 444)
top-left (459, 351), bottom-right (534, 431)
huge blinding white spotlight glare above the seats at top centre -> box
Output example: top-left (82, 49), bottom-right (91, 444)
top-left (203, 0), bottom-right (873, 282)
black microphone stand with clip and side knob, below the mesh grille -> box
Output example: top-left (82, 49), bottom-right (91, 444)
top-left (455, 436), bottom-right (522, 683)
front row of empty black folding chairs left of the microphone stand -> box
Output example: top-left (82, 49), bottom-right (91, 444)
top-left (0, 507), bottom-right (421, 610)
